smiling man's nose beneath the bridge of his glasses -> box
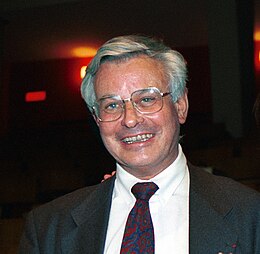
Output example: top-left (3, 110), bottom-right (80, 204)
top-left (121, 101), bottom-right (144, 128)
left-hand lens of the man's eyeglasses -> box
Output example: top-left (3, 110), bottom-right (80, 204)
top-left (95, 97), bottom-right (123, 122)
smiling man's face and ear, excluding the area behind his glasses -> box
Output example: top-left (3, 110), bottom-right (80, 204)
top-left (94, 56), bottom-right (188, 179)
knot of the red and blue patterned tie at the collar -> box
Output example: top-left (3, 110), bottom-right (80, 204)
top-left (131, 182), bottom-right (159, 201)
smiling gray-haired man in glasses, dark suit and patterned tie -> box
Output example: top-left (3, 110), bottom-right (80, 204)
top-left (20, 36), bottom-right (260, 254)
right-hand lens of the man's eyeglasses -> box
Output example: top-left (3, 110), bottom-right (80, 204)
top-left (132, 88), bottom-right (162, 114)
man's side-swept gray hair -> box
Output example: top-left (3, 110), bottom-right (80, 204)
top-left (81, 35), bottom-right (187, 111)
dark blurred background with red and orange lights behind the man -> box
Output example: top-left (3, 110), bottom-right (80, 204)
top-left (0, 0), bottom-right (260, 253)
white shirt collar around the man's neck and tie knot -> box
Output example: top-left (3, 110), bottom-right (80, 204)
top-left (114, 144), bottom-right (187, 204)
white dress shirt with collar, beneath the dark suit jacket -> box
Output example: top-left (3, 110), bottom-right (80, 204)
top-left (104, 145), bottom-right (189, 254)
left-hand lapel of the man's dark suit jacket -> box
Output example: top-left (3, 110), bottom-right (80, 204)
top-left (62, 177), bottom-right (115, 254)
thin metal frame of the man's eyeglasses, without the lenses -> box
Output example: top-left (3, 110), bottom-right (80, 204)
top-left (92, 87), bottom-right (172, 122)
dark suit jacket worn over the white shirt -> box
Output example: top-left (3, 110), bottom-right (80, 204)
top-left (19, 165), bottom-right (260, 254)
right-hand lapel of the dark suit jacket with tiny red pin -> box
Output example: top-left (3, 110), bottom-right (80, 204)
top-left (189, 166), bottom-right (238, 254)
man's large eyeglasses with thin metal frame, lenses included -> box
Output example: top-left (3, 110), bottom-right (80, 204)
top-left (92, 87), bottom-right (171, 122)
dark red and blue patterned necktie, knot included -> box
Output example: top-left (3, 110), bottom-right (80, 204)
top-left (120, 182), bottom-right (159, 254)
